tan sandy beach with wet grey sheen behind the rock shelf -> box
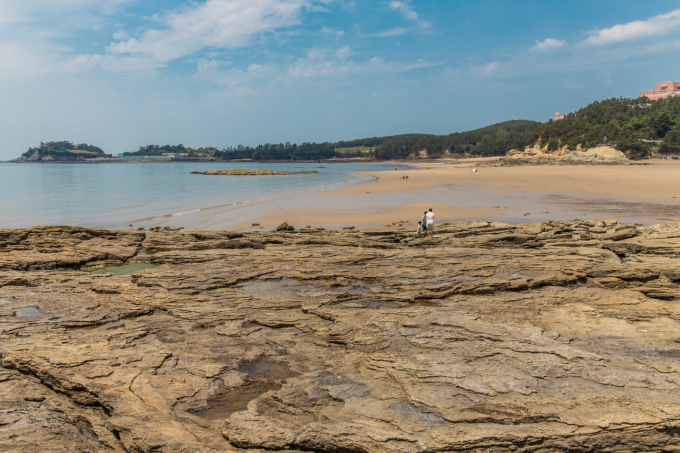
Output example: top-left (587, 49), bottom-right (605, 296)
top-left (230, 159), bottom-right (680, 229)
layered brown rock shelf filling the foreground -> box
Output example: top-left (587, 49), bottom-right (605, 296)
top-left (0, 220), bottom-right (680, 453)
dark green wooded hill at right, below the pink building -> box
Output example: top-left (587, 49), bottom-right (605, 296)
top-left (515, 97), bottom-right (680, 159)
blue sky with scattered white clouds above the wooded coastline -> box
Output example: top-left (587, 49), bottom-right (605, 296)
top-left (0, 0), bottom-right (680, 160)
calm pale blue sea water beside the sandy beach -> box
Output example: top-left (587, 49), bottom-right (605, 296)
top-left (0, 162), bottom-right (403, 228)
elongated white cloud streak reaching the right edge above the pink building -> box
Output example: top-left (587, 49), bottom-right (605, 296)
top-left (583, 9), bottom-right (680, 46)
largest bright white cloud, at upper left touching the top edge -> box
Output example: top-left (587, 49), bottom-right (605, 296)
top-left (109, 0), bottom-right (329, 62)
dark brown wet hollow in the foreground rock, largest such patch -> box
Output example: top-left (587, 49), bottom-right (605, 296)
top-left (190, 357), bottom-right (298, 421)
